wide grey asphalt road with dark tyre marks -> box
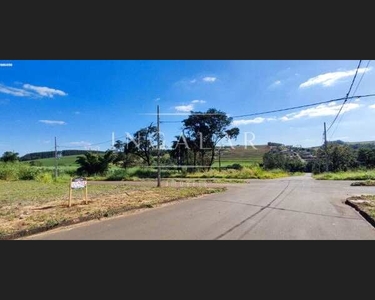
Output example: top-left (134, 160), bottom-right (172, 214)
top-left (27, 176), bottom-right (375, 240)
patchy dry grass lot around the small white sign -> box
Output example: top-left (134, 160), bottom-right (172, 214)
top-left (0, 181), bottom-right (225, 239)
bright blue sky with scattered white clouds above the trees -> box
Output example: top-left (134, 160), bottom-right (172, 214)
top-left (0, 60), bottom-right (375, 154)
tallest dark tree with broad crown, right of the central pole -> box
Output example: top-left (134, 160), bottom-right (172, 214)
top-left (182, 108), bottom-right (240, 169)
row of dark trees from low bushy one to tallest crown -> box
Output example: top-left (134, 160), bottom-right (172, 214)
top-left (77, 108), bottom-right (240, 175)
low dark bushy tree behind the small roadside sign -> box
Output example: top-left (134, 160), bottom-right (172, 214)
top-left (76, 151), bottom-right (114, 176)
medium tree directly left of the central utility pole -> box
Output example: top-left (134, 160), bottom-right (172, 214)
top-left (126, 123), bottom-right (157, 166)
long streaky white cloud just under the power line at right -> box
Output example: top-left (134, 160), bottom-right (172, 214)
top-left (280, 102), bottom-right (360, 121)
